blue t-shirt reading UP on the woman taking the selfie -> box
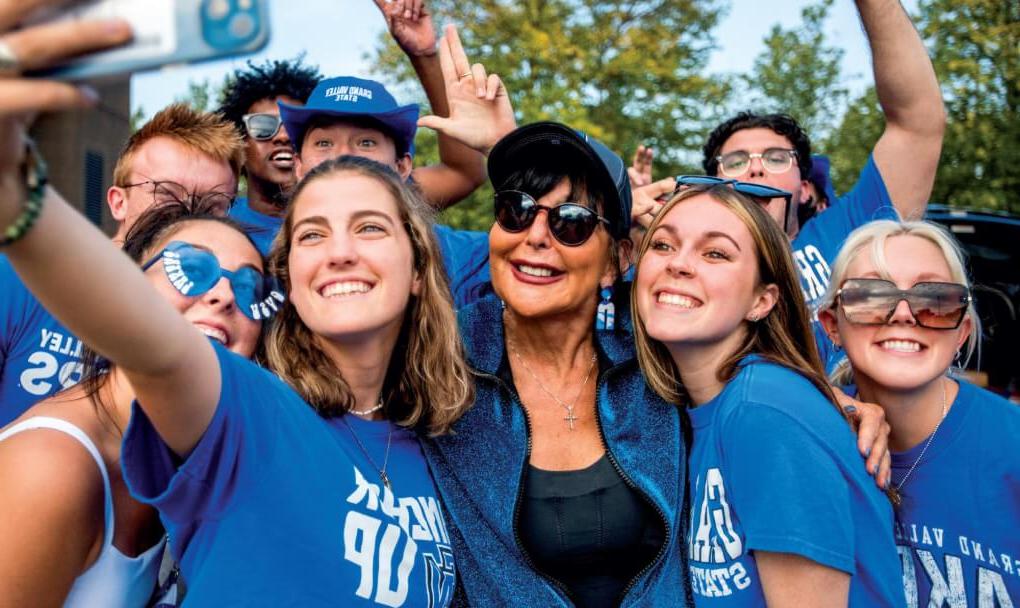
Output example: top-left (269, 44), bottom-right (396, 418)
top-left (122, 345), bottom-right (455, 608)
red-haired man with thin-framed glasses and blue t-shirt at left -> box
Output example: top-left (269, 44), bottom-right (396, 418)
top-left (0, 104), bottom-right (241, 426)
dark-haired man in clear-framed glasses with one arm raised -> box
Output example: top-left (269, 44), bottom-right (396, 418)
top-left (702, 0), bottom-right (946, 314)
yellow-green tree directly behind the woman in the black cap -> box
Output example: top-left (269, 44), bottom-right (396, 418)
top-left (369, 0), bottom-right (729, 229)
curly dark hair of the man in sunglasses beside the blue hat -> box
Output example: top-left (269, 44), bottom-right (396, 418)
top-left (219, 55), bottom-right (322, 131)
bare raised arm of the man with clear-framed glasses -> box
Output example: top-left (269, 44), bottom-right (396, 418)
top-left (857, 0), bottom-right (946, 219)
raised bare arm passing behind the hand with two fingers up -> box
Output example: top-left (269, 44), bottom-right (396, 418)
top-left (375, 0), bottom-right (486, 209)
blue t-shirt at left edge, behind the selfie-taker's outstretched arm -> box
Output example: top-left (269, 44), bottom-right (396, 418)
top-left (0, 255), bottom-right (82, 426)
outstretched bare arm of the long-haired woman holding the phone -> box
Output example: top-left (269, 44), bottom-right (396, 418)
top-left (0, 182), bottom-right (220, 456)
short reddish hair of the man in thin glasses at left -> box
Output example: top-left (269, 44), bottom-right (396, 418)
top-left (113, 103), bottom-right (244, 187)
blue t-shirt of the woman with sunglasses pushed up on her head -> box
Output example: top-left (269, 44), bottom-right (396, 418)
top-left (687, 357), bottom-right (903, 608)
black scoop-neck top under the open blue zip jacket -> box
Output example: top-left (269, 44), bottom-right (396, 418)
top-left (519, 455), bottom-right (662, 608)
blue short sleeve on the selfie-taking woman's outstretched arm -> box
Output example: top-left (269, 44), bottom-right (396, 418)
top-left (121, 344), bottom-right (297, 526)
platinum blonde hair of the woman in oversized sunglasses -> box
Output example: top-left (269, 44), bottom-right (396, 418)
top-left (818, 219), bottom-right (980, 385)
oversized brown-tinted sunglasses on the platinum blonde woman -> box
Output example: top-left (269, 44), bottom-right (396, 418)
top-left (835, 278), bottom-right (971, 330)
